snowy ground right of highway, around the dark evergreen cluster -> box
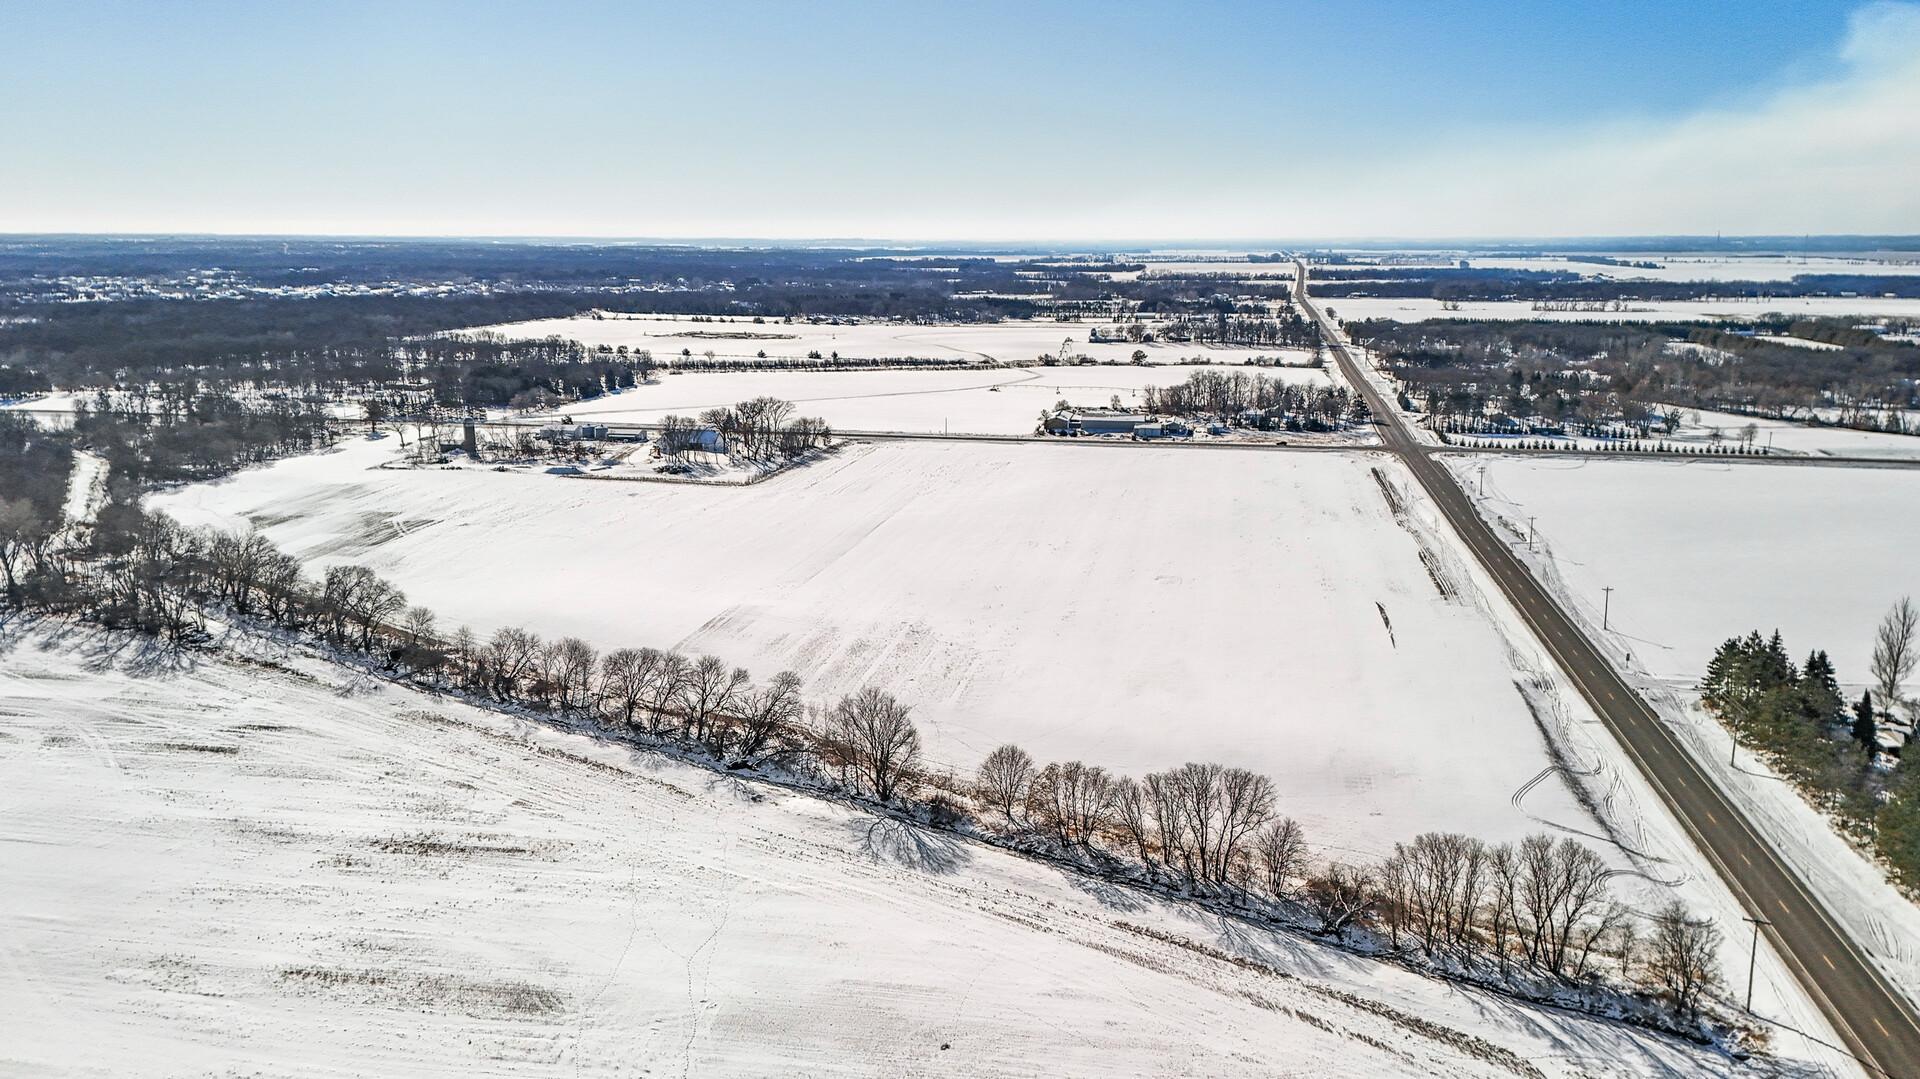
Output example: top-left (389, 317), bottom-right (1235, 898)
top-left (1448, 455), bottom-right (1920, 1006)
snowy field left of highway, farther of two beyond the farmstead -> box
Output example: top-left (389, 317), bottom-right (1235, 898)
top-left (461, 313), bottom-right (1308, 365)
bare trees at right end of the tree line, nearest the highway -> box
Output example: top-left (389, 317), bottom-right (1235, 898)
top-left (972, 745), bottom-right (1718, 1021)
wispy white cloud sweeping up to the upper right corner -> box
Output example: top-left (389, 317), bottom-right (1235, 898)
top-left (1277, 2), bottom-right (1920, 236)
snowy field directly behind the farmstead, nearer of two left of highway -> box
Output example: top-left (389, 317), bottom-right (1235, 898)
top-left (518, 365), bottom-right (1344, 440)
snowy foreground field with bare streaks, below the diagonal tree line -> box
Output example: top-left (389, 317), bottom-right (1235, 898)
top-left (0, 630), bottom-right (1797, 1077)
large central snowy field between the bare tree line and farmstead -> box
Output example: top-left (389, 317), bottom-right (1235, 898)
top-left (154, 431), bottom-right (1582, 851)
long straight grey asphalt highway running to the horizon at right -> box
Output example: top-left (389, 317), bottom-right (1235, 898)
top-left (1296, 265), bottom-right (1920, 1079)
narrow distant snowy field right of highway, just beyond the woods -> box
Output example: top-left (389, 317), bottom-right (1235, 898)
top-left (1319, 296), bottom-right (1920, 323)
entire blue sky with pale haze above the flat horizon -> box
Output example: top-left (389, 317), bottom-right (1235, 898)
top-left (0, 0), bottom-right (1920, 240)
